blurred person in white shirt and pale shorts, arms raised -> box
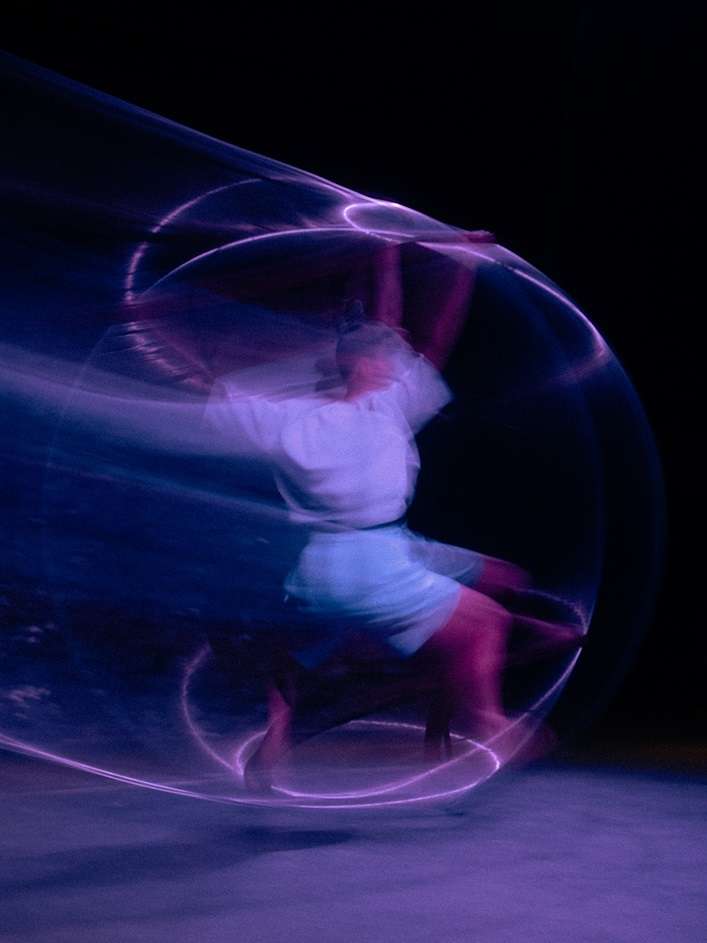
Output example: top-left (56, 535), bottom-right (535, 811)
top-left (207, 247), bottom-right (580, 771)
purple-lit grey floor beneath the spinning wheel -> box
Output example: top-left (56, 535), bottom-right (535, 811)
top-left (0, 761), bottom-right (707, 943)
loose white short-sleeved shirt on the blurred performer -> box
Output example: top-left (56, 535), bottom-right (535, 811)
top-left (205, 351), bottom-right (451, 528)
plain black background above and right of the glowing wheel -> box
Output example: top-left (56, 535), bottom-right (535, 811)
top-left (3, 3), bottom-right (707, 744)
